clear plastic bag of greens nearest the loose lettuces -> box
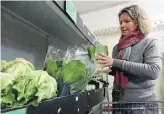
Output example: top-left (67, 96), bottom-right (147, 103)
top-left (44, 45), bottom-right (67, 96)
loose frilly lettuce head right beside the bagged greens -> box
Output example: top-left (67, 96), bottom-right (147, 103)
top-left (13, 70), bottom-right (57, 106)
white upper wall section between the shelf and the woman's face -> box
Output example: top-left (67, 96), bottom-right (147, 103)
top-left (80, 3), bottom-right (131, 31)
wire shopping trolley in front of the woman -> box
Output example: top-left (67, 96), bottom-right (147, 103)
top-left (89, 74), bottom-right (164, 114)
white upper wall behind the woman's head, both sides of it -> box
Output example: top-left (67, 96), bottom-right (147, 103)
top-left (80, 0), bottom-right (164, 32)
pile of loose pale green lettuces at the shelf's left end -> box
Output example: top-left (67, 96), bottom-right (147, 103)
top-left (0, 60), bottom-right (57, 108)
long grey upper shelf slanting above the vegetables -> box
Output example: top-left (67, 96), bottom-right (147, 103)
top-left (1, 1), bottom-right (90, 45)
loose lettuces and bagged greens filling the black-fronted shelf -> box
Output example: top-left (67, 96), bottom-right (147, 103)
top-left (0, 45), bottom-right (108, 109)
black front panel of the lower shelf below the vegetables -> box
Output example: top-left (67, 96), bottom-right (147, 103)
top-left (1, 87), bottom-right (107, 114)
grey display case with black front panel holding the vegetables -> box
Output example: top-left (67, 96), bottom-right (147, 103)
top-left (1, 1), bottom-right (107, 114)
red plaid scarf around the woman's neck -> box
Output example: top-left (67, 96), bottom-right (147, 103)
top-left (114, 33), bottom-right (144, 88)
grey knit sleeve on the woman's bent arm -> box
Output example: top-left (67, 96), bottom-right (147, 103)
top-left (112, 39), bottom-right (162, 80)
